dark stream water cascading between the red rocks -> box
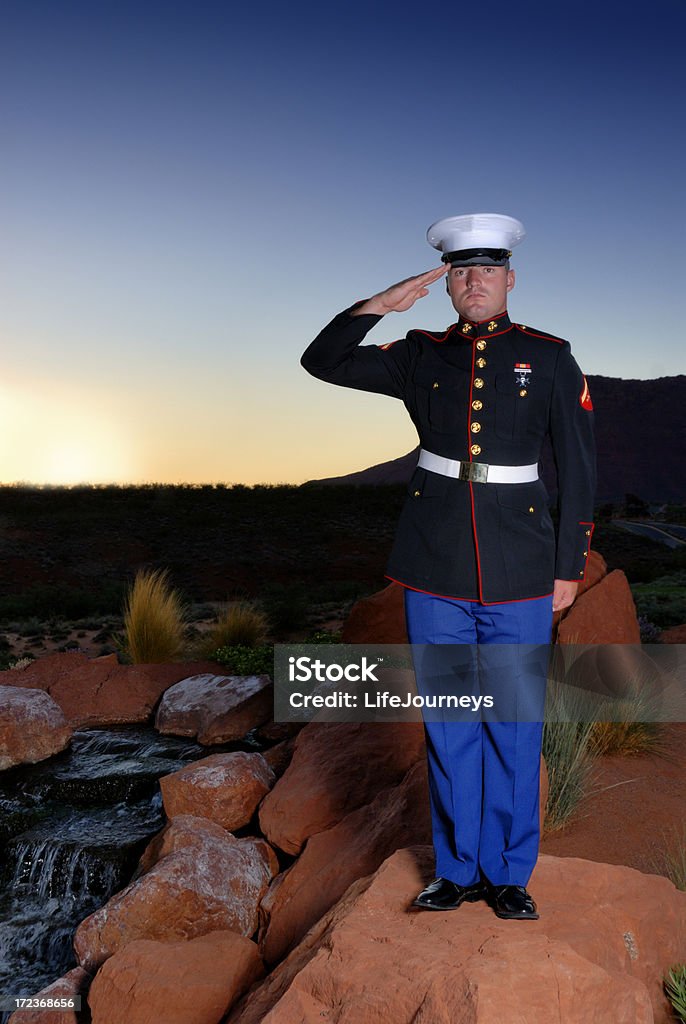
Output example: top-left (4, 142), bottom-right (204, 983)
top-left (0, 726), bottom-right (259, 1024)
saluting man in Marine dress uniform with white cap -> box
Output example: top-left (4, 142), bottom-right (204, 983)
top-left (301, 214), bottom-right (595, 920)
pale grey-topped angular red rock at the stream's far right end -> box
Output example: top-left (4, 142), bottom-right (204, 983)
top-left (155, 673), bottom-right (273, 745)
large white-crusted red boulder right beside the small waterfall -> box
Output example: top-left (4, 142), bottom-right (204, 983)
top-left (74, 816), bottom-right (273, 971)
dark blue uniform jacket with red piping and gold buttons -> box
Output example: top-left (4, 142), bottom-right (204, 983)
top-left (301, 303), bottom-right (596, 604)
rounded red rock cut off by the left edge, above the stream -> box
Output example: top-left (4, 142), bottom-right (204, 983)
top-left (0, 688), bottom-right (74, 770)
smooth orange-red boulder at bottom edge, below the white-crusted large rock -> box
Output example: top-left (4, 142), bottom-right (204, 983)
top-left (88, 931), bottom-right (264, 1024)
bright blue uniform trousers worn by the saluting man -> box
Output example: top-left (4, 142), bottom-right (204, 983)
top-left (404, 588), bottom-right (553, 886)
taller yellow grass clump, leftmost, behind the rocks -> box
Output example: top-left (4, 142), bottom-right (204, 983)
top-left (113, 569), bottom-right (185, 665)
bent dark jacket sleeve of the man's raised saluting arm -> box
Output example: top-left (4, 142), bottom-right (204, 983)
top-left (300, 303), bottom-right (414, 398)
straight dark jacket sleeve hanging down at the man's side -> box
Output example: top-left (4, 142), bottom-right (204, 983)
top-left (550, 341), bottom-right (596, 582)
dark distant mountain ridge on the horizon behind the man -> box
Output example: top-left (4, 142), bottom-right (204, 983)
top-left (308, 374), bottom-right (686, 502)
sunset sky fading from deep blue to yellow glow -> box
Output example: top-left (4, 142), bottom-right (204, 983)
top-left (0, 0), bottom-right (686, 483)
